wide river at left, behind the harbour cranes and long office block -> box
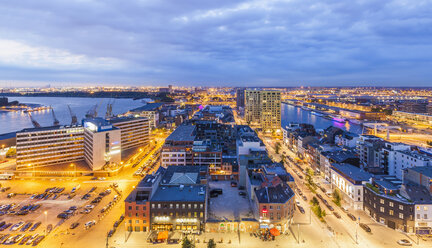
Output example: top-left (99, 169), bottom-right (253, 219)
top-left (0, 97), bottom-right (143, 134)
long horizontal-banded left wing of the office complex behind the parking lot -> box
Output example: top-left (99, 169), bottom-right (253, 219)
top-left (16, 126), bottom-right (84, 168)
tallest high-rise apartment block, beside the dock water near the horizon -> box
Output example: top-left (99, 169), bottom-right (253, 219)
top-left (245, 90), bottom-right (281, 131)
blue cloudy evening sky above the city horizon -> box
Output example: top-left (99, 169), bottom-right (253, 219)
top-left (0, 0), bottom-right (432, 86)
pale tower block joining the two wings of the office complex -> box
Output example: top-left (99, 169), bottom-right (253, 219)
top-left (83, 117), bottom-right (121, 170)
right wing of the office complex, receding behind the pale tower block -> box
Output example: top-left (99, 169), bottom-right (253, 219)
top-left (109, 117), bottom-right (150, 151)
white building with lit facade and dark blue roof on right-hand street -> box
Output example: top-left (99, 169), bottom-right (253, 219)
top-left (330, 164), bottom-right (371, 210)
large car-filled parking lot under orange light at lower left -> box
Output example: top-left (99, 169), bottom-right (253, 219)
top-left (0, 179), bottom-right (125, 245)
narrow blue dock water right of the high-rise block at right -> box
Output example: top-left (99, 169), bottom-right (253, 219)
top-left (281, 104), bottom-right (362, 134)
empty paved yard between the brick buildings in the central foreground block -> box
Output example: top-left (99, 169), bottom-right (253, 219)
top-left (209, 181), bottom-right (253, 220)
